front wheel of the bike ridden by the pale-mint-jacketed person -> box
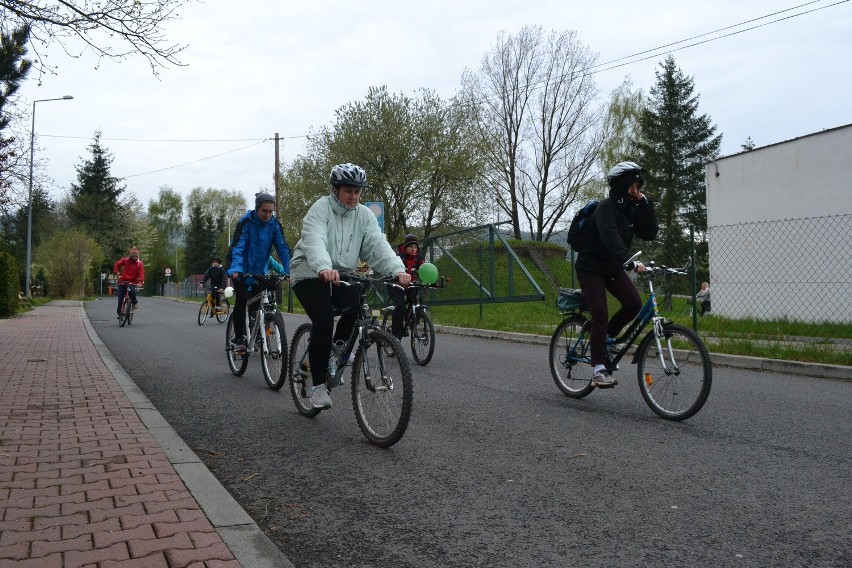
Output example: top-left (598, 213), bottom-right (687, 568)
top-left (352, 329), bottom-right (414, 448)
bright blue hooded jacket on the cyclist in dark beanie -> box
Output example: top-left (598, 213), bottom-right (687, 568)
top-left (228, 211), bottom-right (290, 276)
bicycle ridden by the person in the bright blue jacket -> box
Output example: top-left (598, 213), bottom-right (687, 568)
top-left (225, 274), bottom-right (289, 390)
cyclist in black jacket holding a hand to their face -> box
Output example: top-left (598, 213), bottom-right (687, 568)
top-left (574, 162), bottom-right (659, 388)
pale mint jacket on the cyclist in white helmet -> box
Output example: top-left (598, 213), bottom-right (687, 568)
top-left (290, 195), bottom-right (405, 285)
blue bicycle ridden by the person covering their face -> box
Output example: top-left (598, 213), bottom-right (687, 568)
top-left (550, 253), bottom-right (713, 420)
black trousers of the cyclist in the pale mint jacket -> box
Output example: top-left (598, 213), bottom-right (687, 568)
top-left (293, 278), bottom-right (361, 385)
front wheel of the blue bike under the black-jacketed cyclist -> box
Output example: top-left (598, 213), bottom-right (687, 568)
top-left (636, 324), bottom-right (713, 420)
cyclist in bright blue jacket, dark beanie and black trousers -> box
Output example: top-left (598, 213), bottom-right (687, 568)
top-left (227, 193), bottom-right (290, 355)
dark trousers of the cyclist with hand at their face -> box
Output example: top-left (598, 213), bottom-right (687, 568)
top-left (577, 272), bottom-right (642, 365)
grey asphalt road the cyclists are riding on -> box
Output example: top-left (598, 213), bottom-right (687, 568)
top-left (86, 298), bottom-right (852, 567)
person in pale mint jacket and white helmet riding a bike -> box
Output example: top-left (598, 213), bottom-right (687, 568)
top-left (290, 164), bottom-right (411, 408)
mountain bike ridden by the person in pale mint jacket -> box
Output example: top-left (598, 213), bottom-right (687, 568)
top-left (289, 272), bottom-right (413, 447)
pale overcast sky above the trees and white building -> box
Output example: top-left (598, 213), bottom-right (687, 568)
top-left (8, 0), bottom-right (852, 213)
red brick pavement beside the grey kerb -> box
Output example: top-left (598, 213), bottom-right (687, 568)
top-left (0, 305), bottom-right (240, 568)
